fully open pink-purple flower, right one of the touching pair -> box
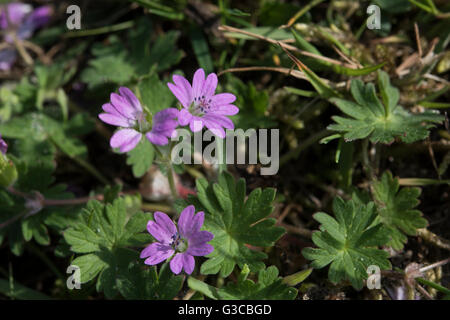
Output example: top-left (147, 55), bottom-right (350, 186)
top-left (167, 68), bottom-right (239, 138)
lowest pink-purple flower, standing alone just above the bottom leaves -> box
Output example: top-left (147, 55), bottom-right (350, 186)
top-left (141, 205), bottom-right (214, 274)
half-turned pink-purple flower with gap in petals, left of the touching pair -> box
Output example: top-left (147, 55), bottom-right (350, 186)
top-left (99, 87), bottom-right (178, 152)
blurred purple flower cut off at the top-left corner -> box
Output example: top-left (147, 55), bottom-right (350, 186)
top-left (0, 2), bottom-right (52, 70)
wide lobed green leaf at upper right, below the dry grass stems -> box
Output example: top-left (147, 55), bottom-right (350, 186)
top-left (328, 71), bottom-right (444, 144)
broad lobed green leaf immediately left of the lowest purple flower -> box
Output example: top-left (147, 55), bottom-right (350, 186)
top-left (64, 198), bottom-right (150, 298)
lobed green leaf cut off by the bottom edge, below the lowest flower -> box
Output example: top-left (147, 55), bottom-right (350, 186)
top-left (188, 265), bottom-right (297, 300)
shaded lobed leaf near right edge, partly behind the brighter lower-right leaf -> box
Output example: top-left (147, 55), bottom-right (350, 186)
top-left (373, 171), bottom-right (428, 250)
